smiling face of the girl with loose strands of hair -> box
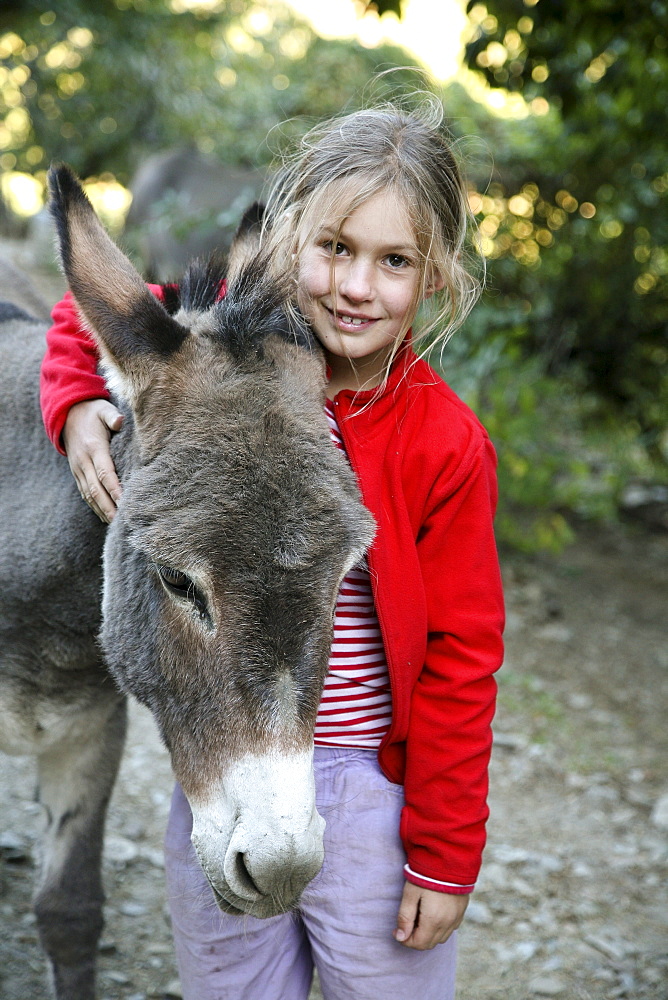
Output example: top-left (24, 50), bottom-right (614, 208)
top-left (298, 191), bottom-right (428, 385)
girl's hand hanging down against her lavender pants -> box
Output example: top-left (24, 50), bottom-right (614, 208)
top-left (394, 882), bottom-right (469, 951)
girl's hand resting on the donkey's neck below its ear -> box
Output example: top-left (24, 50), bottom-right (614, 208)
top-left (63, 399), bottom-right (123, 524)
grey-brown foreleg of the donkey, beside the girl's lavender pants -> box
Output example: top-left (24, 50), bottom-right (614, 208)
top-left (34, 694), bottom-right (126, 1000)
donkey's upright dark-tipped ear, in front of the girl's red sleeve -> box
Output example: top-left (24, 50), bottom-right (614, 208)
top-left (48, 165), bottom-right (188, 399)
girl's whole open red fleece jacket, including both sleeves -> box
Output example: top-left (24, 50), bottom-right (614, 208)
top-left (41, 286), bottom-right (503, 892)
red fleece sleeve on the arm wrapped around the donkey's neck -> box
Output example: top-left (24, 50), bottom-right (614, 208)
top-left (40, 285), bottom-right (163, 455)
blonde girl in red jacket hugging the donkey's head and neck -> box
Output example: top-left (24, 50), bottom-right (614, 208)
top-left (42, 97), bottom-right (503, 1000)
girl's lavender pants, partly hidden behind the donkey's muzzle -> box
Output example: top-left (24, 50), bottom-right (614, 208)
top-left (165, 747), bottom-right (456, 1000)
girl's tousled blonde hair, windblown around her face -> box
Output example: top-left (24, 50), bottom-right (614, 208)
top-left (264, 95), bottom-right (484, 377)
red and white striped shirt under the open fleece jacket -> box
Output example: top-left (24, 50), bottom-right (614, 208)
top-left (315, 400), bottom-right (392, 750)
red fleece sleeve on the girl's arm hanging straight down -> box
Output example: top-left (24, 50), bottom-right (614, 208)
top-left (401, 437), bottom-right (503, 892)
